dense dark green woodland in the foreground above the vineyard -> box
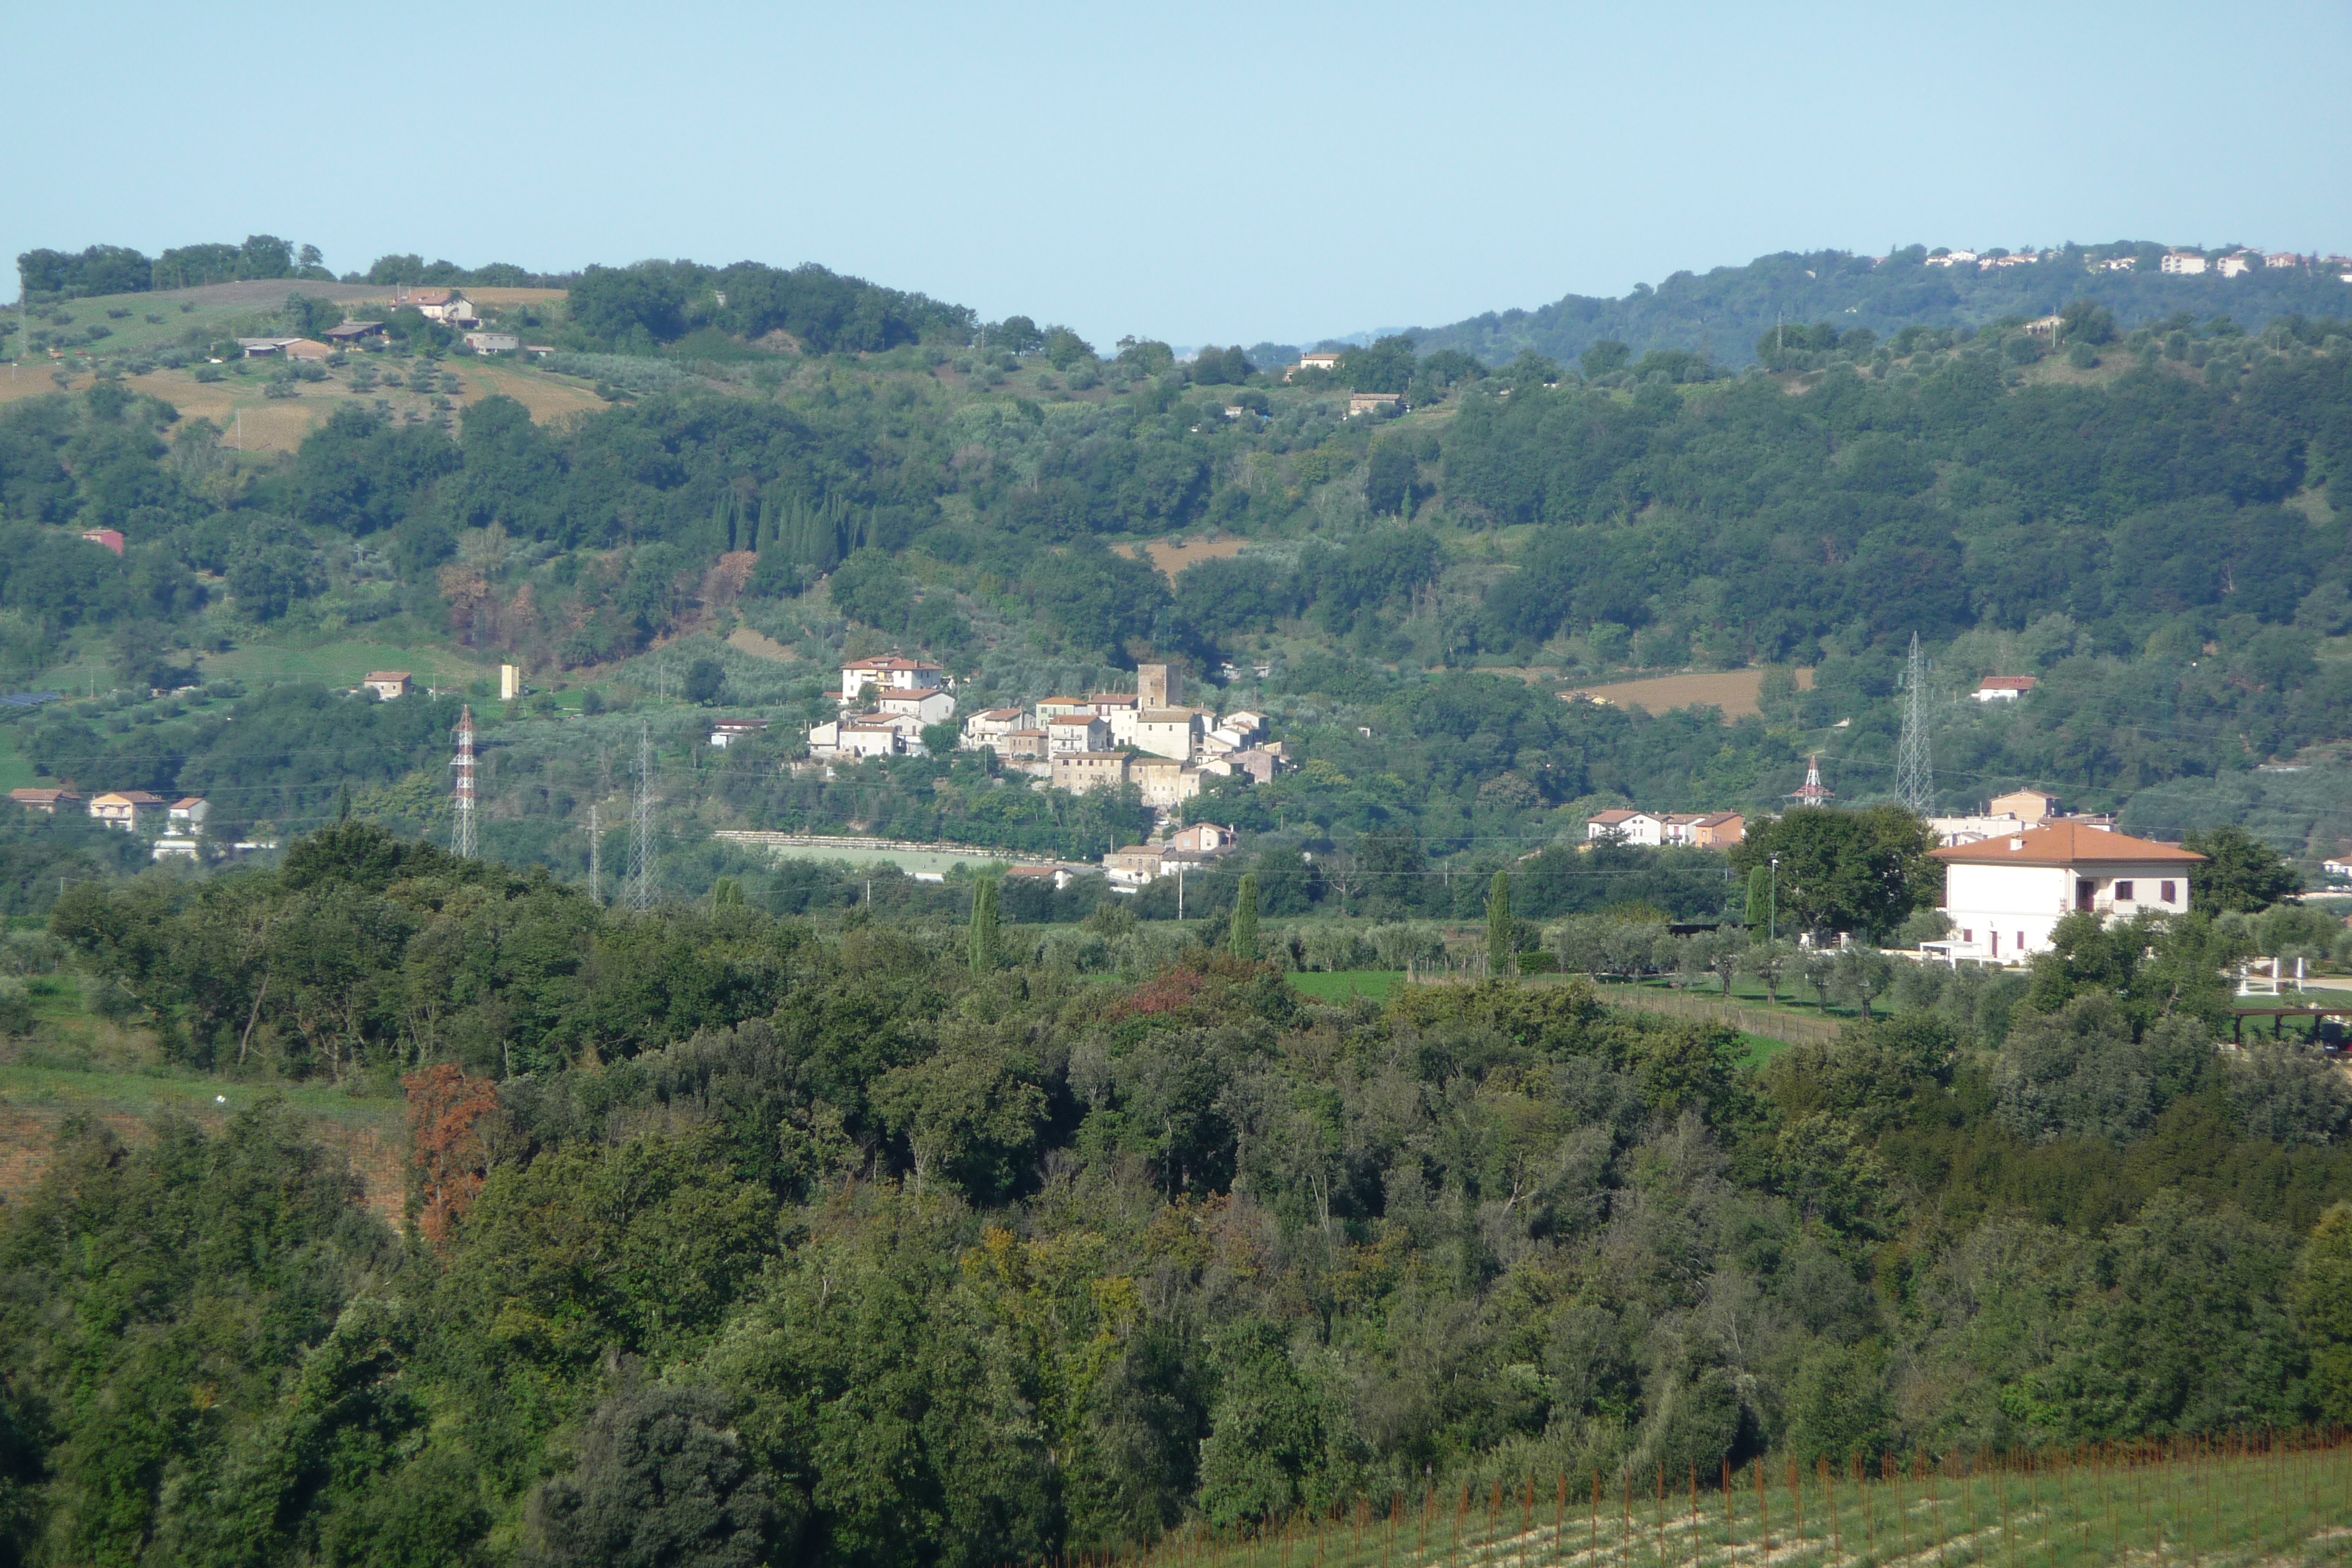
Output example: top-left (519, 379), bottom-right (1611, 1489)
top-left (13, 825), bottom-right (2352, 1568)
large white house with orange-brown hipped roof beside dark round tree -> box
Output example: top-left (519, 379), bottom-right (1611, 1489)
top-left (1929, 820), bottom-right (2204, 961)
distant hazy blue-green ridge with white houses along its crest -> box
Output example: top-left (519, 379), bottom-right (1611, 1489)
top-left (1414, 242), bottom-right (2352, 364)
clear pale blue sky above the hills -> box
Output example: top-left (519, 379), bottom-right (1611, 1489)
top-left (23, 0), bottom-right (2352, 346)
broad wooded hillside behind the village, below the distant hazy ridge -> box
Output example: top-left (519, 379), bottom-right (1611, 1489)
top-left (0, 264), bottom-right (2352, 875)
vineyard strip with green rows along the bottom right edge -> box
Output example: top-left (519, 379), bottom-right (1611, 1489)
top-left (1103, 1434), bottom-right (2352, 1568)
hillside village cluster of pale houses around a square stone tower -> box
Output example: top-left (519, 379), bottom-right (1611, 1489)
top-left (804, 654), bottom-right (1287, 811)
